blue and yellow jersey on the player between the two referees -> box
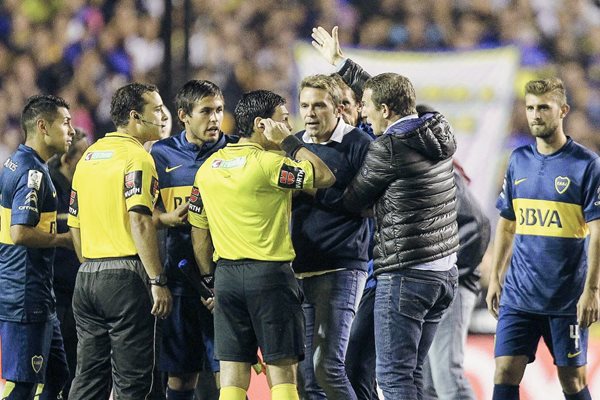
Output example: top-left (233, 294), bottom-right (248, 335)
top-left (150, 131), bottom-right (238, 295)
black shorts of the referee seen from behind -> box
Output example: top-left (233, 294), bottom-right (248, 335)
top-left (214, 260), bottom-right (304, 364)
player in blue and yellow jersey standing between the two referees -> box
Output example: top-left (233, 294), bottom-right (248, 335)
top-left (150, 80), bottom-right (237, 400)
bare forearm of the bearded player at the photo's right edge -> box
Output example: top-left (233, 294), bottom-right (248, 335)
top-left (577, 219), bottom-right (600, 328)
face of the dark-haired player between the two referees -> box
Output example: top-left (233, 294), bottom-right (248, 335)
top-left (179, 96), bottom-right (224, 143)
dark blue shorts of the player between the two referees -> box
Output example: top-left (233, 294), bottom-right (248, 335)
top-left (159, 295), bottom-right (219, 374)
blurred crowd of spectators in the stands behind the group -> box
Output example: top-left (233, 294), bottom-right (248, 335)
top-left (0, 0), bottom-right (600, 161)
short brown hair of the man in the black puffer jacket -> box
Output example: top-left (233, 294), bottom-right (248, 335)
top-left (363, 72), bottom-right (417, 117)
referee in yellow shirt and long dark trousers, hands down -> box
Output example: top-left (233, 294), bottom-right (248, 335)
top-left (68, 83), bottom-right (171, 400)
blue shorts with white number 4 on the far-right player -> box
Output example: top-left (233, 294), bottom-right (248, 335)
top-left (494, 306), bottom-right (588, 367)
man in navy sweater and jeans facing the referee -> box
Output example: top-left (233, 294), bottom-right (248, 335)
top-left (292, 75), bottom-right (371, 400)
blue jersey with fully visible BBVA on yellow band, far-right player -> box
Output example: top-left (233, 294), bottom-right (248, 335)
top-left (496, 138), bottom-right (600, 315)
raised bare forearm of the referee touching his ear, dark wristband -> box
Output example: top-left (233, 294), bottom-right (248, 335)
top-left (261, 118), bottom-right (335, 189)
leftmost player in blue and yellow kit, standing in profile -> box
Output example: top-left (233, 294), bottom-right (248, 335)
top-left (0, 95), bottom-right (75, 400)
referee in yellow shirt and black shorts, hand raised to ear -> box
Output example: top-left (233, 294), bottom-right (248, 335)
top-left (188, 90), bottom-right (335, 400)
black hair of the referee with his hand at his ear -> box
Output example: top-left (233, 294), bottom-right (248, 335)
top-left (234, 90), bottom-right (285, 137)
